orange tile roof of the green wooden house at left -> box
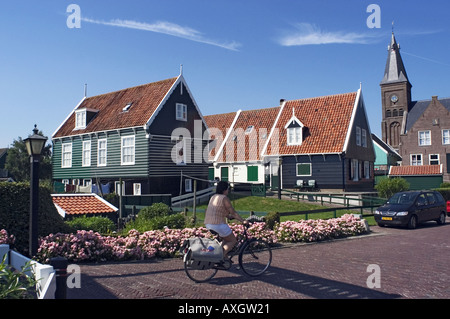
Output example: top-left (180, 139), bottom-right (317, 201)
top-left (53, 77), bottom-right (178, 137)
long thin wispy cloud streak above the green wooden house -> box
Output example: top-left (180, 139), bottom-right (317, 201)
top-left (82, 18), bottom-right (241, 51)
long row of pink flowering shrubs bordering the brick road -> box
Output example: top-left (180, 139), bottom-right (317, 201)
top-left (0, 214), bottom-right (366, 262)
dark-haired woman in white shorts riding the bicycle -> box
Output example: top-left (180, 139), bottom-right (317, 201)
top-left (205, 181), bottom-right (247, 258)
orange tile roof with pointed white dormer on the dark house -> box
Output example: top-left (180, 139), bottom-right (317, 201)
top-left (265, 92), bottom-right (357, 155)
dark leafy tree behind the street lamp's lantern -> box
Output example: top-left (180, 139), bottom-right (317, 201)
top-left (5, 131), bottom-right (52, 182)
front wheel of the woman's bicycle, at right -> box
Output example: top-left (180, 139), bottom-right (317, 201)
top-left (239, 239), bottom-right (272, 276)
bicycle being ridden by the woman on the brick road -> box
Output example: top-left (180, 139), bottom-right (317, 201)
top-left (183, 223), bottom-right (272, 283)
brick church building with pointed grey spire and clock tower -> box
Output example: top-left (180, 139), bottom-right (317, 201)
top-left (380, 33), bottom-right (450, 182)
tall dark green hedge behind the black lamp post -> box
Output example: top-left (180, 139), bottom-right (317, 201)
top-left (0, 182), bottom-right (73, 254)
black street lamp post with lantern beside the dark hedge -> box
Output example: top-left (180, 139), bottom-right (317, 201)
top-left (24, 125), bottom-right (47, 257)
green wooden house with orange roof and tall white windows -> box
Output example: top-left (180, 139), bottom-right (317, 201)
top-left (52, 74), bottom-right (208, 195)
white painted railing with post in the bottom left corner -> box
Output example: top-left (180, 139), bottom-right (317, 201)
top-left (0, 245), bottom-right (56, 299)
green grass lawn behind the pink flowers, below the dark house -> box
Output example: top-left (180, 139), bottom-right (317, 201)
top-left (183, 193), bottom-right (375, 225)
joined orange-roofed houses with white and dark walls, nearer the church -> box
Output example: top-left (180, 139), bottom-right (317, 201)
top-left (205, 88), bottom-right (375, 191)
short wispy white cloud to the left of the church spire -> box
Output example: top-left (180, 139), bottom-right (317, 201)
top-left (278, 23), bottom-right (379, 46)
